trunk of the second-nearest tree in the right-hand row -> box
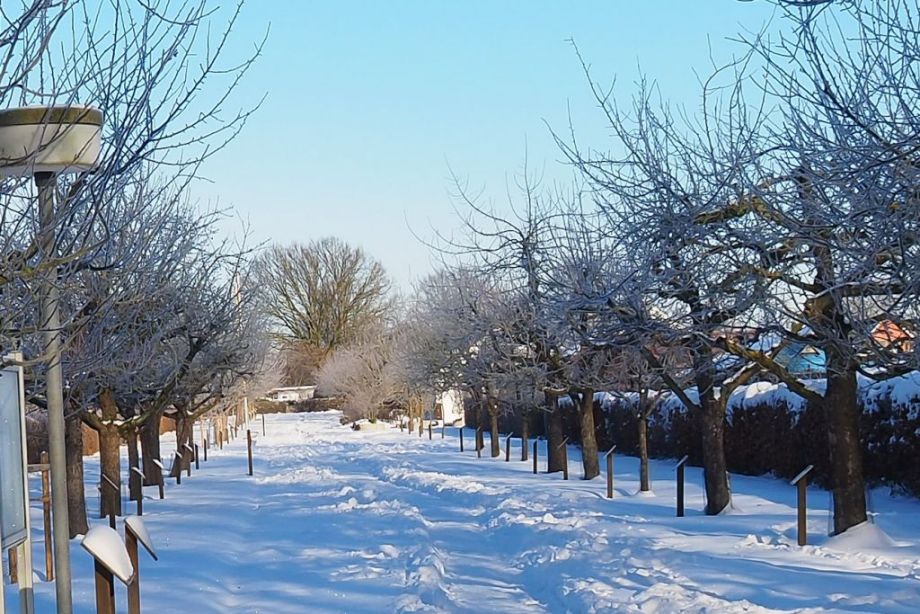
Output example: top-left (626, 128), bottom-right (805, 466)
top-left (696, 368), bottom-right (731, 516)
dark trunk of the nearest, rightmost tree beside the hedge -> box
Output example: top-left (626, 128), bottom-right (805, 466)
top-left (824, 349), bottom-right (866, 535)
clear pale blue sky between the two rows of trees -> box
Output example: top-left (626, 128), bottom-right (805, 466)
top-left (195, 0), bottom-right (773, 288)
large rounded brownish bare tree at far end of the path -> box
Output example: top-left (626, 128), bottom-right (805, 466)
top-left (258, 237), bottom-right (391, 384)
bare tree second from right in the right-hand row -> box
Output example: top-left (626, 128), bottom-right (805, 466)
top-left (559, 57), bottom-right (759, 514)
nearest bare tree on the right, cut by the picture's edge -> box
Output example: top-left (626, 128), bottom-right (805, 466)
top-left (698, 1), bottom-right (920, 533)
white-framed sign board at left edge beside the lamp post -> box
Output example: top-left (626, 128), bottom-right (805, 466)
top-left (0, 360), bottom-right (29, 548)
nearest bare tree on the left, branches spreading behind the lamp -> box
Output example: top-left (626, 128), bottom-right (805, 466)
top-left (0, 0), bottom-right (268, 548)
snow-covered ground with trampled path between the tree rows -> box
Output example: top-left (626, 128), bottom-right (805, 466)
top-left (6, 412), bottom-right (920, 614)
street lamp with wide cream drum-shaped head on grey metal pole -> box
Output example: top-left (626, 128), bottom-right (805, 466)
top-left (0, 105), bottom-right (102, 614)
